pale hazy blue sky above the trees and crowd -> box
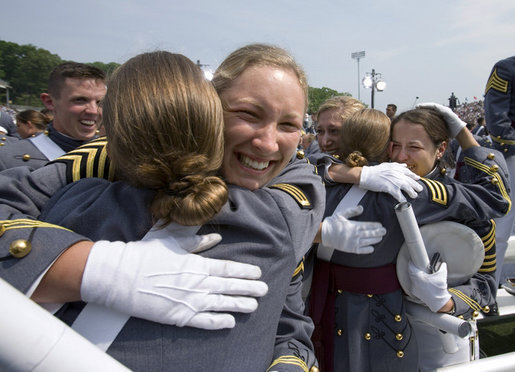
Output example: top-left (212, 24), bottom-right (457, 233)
top-left (0, 0), bottom-right (515, 113)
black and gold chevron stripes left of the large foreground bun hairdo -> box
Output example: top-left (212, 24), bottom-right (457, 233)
top-left (50, 137), bottom-right (114, 183)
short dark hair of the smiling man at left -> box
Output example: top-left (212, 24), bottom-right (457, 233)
top-left (48, 62), bottom-right (106, 98)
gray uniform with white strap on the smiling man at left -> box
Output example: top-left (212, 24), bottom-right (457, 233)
top-left (0, 124), bottom-right (86, 171)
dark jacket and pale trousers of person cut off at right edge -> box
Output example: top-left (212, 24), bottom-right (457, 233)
top-left (485, 56), bottom-right (515, 284)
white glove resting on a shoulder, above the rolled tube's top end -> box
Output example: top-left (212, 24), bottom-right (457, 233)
top-left (359, 163), bottom-right (422, 202)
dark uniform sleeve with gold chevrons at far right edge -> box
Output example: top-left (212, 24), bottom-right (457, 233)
top-left (485, 56), bottom-right (515, 156)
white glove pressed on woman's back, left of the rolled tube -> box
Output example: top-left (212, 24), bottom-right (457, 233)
top-left (317, 205), bottom-right (386, 261)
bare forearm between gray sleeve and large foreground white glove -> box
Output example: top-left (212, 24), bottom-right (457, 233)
top-left (31, 241), bottom-right (94, 303)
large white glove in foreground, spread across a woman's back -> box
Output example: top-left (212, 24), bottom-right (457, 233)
top-left (81, 234), bottom-right (268, 329)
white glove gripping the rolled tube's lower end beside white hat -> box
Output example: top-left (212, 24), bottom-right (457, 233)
top-left (408, 260), bottom-right (451, 313)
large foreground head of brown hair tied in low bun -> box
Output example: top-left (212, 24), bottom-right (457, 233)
top-left (103, 51), bottom-right (227, 225)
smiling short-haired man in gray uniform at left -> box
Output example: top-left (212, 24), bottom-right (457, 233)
top-left (0, 62), bottom-right (106, 170)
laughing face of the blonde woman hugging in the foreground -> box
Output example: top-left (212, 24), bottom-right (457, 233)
top-left (220, 66), bottom-right (305, 190)
